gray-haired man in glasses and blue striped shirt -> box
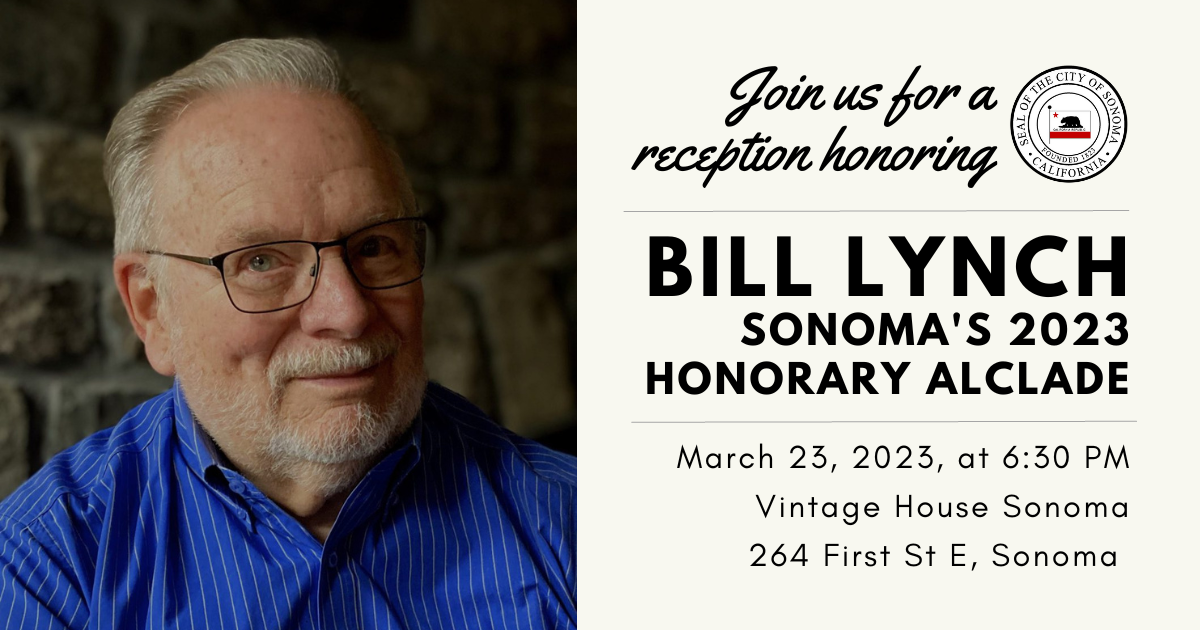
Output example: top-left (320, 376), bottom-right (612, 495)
top-left (0, 40), bottom-right (576, 629)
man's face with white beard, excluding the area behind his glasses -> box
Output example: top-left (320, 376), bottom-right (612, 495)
top-left (152, 88), bottom-right (425, 475)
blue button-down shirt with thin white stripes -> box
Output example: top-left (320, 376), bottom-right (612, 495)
top-left (0, 382), bottom-right (576, 630)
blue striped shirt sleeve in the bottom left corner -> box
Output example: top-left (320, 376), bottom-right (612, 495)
top-left (0, 523), bottom-right (89, 630)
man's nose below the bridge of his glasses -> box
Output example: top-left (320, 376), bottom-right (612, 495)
top-left (300, 248), bottom-right (374, 338)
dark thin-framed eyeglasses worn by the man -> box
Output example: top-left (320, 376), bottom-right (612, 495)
top-left (144, 217), bottom-right (426, 313)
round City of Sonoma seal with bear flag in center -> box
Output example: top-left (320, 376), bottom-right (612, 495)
top-left (1010, 66), bottom-right (1129, 181)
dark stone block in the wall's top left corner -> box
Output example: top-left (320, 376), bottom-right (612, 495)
top-left (0, 0), bottom-right (115, 125)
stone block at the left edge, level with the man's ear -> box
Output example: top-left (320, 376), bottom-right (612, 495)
top-left (0, 270), bottom-right (96, 365)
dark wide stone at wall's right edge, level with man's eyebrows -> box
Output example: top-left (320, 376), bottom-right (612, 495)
top-left (442, 179), bottom-right (575, 256)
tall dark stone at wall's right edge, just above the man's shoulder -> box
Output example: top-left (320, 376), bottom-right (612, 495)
top-left (464, 257), bottom-right (575, 437)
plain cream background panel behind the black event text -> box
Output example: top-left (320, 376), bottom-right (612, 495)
top-left (578, 2), bottom-right (1198, 628)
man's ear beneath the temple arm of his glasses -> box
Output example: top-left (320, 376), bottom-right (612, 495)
top-left (113, 253), bottom-right (175, 377)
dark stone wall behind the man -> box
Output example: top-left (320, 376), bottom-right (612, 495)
top-left (0, 0), bottom-right (575, 497)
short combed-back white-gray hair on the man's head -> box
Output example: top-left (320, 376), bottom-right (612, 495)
top-left (104, 38), bottom-right (414, 253)
